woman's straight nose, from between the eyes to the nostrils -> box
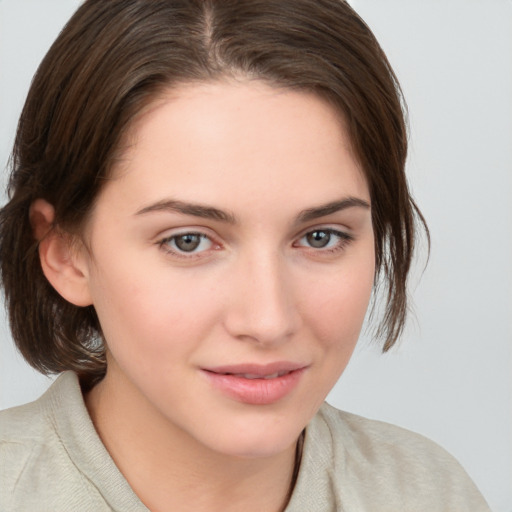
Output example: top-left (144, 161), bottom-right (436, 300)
top-left (225, 252), bottom-right (300, 346)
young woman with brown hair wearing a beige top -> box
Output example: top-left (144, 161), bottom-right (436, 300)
top-left (1, 0), bottom-right (487, 511)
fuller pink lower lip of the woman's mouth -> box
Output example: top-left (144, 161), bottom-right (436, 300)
top-left (203, 368), bottom-right (305, 405)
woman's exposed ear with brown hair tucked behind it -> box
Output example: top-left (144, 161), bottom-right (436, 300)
top-left (29, 199), bottom-right (92, 306)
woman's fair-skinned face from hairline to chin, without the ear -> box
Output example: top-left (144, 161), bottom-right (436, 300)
top-left (83, 82), bottom-right (375, 457)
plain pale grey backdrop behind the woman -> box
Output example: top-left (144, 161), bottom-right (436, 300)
top-left (0, 0), bottom-right (512, 512)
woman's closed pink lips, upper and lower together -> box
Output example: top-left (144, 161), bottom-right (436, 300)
top-left (202, 362), bottom-right (306, 405)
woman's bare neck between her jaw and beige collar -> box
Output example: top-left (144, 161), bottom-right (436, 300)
top-left (86, 366), bottom-right (296, 512)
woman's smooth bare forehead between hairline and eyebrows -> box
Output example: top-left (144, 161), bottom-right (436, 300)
top-left (100, 81), bottom-right (369, 218)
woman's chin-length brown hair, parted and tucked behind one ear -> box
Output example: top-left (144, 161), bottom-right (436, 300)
top-left (0, 0), bottom-right (428, 382)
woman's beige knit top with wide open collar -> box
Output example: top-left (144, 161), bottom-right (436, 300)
top-left (0, 372), bottom-right (489, 512)
